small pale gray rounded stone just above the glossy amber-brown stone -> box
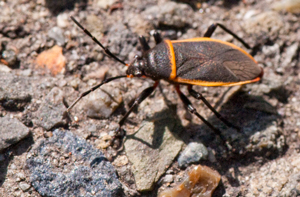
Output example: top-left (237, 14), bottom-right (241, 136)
top-left (178, 142), bottom-right (208, 167)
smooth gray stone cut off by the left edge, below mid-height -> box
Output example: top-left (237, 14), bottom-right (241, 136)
top-left (0, 116), bottom-right (29, 151)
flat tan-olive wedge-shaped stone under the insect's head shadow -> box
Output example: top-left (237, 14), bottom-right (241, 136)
top-left (124, 100), bottom-right (183, 191)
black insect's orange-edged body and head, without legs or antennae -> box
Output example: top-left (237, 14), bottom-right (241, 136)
top-left (127, 38), bottom-right (262, 86)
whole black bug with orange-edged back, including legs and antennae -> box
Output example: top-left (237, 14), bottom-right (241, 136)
top-left (67, 17), bottom-right (263, 143)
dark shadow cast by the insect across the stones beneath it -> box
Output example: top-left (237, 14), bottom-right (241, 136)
top-left (126, 85), bottom-right (280, 155)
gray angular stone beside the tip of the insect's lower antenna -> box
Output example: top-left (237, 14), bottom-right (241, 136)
top-left (33, 87), bottom-right (67, 130)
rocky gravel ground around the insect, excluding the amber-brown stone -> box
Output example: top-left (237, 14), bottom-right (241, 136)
top-left (0, 0), bottom-right (300, 197)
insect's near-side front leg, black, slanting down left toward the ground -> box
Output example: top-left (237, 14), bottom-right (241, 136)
top-left (118, 81), bottom-right (159, 130)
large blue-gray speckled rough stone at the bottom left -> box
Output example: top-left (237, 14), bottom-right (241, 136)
top-left (26, 130), bottom-right (122, 197)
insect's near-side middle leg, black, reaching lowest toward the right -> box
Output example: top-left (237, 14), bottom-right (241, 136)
top-left (176, 85), bottom-right (226, 145)
